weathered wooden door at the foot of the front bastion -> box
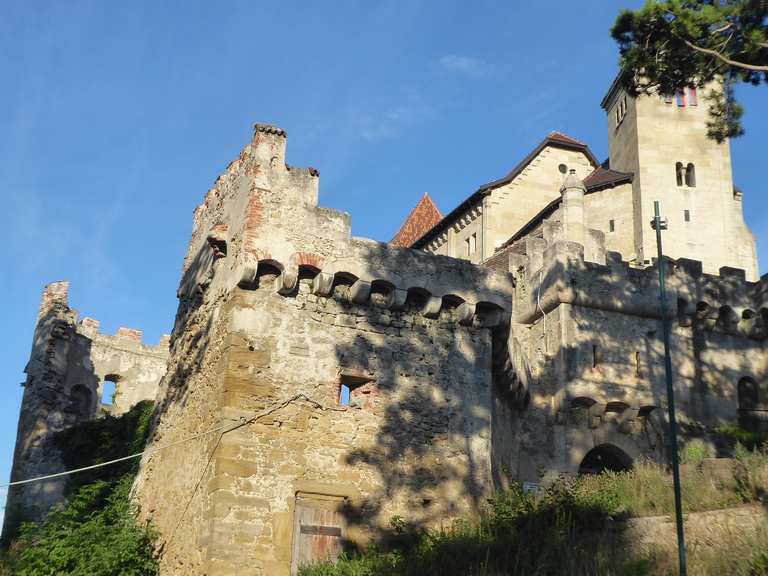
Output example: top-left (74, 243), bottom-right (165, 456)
top-left (291, 493), bottom-right (345, 574)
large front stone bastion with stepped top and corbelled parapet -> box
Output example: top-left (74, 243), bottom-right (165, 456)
top-left (136, 125), bottom-right (511, 575)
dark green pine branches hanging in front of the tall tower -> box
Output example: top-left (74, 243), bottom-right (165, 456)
top-left (611, 0), bottom-right (768, 142)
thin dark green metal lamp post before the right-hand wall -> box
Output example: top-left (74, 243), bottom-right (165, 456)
top-left (651, 201), bottom-right (687, 576)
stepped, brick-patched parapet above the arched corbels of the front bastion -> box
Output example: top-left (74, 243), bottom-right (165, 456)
top-left (178, 125), bottom-right (512, 321)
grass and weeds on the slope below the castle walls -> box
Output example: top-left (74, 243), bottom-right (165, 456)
top-left (300, 444), bottom-right (768, 576)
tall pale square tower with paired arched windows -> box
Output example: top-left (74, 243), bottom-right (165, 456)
top-left (601, 76), bottom-right (758, 280)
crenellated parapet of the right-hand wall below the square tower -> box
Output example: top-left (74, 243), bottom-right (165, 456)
top-left (510, 238), bottom-right (768, 340)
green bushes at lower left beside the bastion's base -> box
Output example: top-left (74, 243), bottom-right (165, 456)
top-left (0, 402), bottom-right (157, 576)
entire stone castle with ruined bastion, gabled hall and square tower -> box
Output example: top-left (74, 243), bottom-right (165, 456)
top-left (4, 77), bottom-right (768, 576)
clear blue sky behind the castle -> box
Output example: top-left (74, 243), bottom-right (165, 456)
top-left (0, 0), bottom-right (768, 512)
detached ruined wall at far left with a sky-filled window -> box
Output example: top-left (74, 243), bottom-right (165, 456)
top-left (3, 282), bottom-right (168, 539)
